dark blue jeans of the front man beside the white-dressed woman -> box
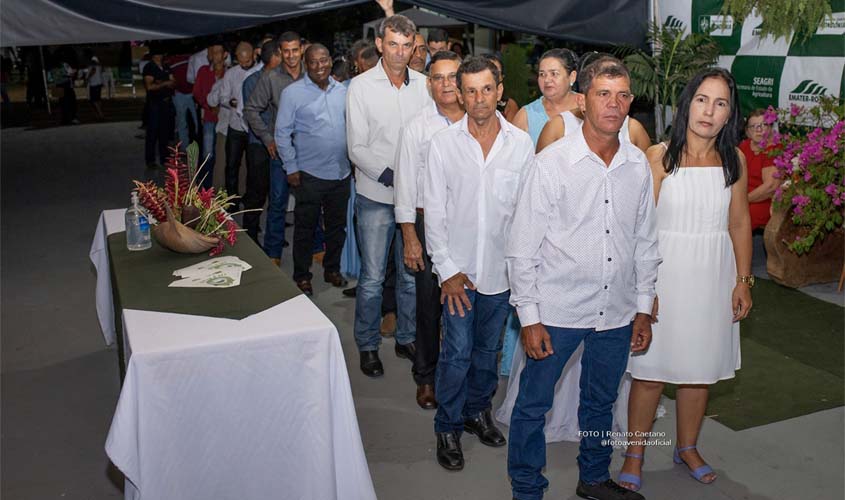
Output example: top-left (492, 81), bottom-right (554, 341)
top-left (508, 324), bottom-right (632, 500)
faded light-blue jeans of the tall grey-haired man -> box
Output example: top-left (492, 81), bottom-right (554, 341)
top-left (355, 194), bottom-right (417, 351)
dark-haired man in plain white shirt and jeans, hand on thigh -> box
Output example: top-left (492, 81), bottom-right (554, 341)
top-left (423, 57), bottom-right (534, 470)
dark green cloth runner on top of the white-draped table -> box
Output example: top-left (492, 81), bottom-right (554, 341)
top-left (108, 232), bottom-right (302, 323)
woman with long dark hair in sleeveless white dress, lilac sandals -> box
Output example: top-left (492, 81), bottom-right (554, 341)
top-left (619, 68), bottom-right (754, 490)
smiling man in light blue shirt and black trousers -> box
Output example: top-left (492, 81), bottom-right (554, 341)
top-left (275, 44), bottom-right (350, 295)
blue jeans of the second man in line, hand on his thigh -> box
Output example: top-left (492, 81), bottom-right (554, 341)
top-left (434, 290), bottom-right (511, 433)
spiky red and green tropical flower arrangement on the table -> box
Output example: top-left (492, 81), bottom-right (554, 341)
top-left (133, 142), bottom-right (243, 257)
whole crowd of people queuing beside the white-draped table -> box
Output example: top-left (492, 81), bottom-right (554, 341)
top-left (130, 5), bottom-right (776, 500)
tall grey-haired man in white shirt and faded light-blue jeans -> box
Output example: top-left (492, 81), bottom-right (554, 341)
top-left (346, 15), bottom-right (431, 377)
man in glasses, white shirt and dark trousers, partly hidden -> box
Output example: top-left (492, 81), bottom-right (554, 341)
top-left (394, 51), bottom-right (464, 410)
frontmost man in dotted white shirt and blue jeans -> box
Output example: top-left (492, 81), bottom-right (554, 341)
top-left (507, 56), bottom-right (660, 500)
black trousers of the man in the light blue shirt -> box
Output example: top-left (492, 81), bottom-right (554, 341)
top-left (293, 171), bottom-right (349, 281)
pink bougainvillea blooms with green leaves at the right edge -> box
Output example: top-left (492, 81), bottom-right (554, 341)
top-left (763, 96), bottom-right (845, 255)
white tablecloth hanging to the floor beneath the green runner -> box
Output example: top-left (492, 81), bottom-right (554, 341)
top-left (92, 210), bottom-right (375, 500)
